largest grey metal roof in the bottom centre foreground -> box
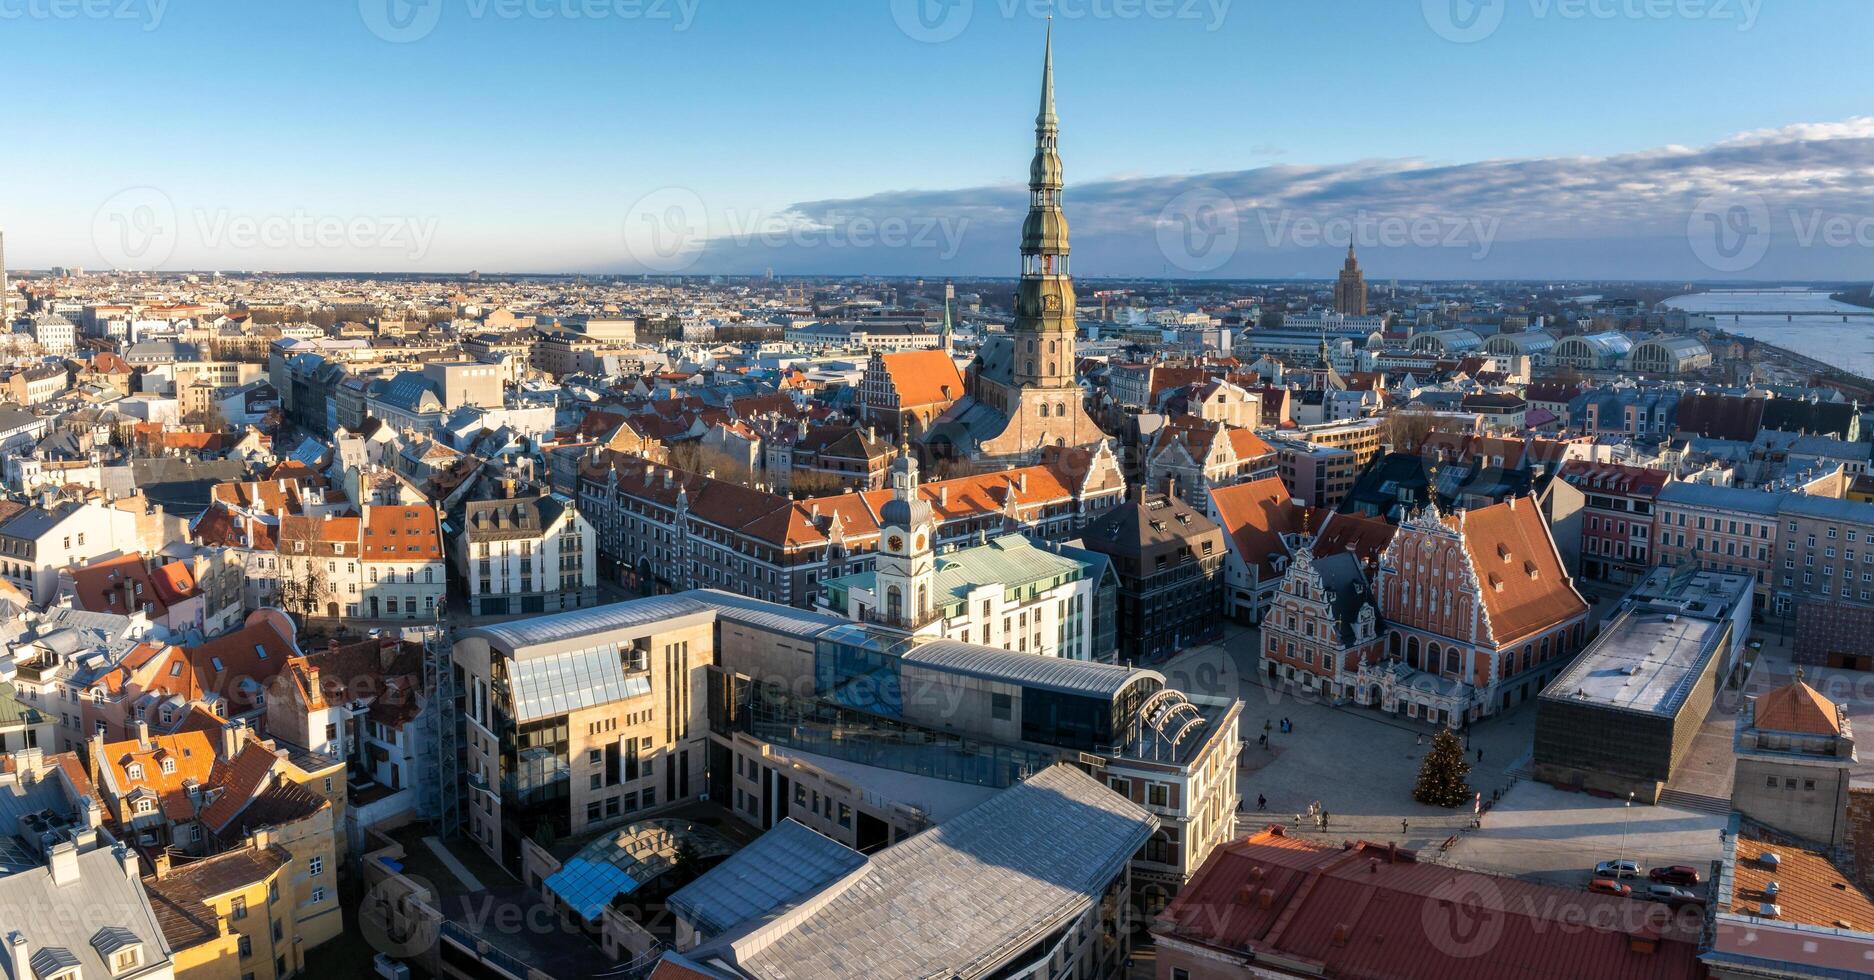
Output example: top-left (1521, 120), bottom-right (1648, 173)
top-left (727, 765), bottom-right (1158, 980)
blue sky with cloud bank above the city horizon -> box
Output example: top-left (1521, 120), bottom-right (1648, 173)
top-left (0, 0), bottom-right (1874, 277)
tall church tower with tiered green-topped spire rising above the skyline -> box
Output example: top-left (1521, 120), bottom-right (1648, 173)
top-left (973, 22), bottom-right (1106, 463)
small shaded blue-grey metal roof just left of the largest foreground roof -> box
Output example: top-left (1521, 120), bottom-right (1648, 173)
top-left (669, 817), bottom-right (866, 939)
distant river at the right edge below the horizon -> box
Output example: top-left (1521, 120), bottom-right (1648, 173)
top-left (1666, 289), bottom-right (1874, 379)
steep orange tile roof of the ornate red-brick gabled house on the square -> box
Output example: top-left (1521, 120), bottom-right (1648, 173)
top-left (1445, 498), bottom-right (1587, 646)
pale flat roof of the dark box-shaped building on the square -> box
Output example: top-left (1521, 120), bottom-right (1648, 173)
top-left (1542, 607), bottom-right (1724, 718)
